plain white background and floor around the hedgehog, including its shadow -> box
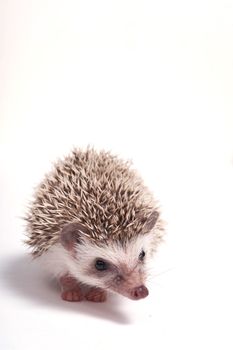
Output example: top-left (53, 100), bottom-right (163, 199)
top-left (0, 0), bottom-right (233, 350)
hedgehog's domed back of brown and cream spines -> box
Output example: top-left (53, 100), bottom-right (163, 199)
top-left (26, 149), bottom-right (160, 255)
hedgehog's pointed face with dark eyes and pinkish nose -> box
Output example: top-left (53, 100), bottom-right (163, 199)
top-left (60, 211), bottom-right (159, 300)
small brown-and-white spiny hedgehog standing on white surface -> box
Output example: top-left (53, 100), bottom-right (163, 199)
top-left (25, 147), bottom-right (164, 302)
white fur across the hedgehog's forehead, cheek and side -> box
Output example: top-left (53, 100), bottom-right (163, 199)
top-left (39, 233), bottom-right (154, 288)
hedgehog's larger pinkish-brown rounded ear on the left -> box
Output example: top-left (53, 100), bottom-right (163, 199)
top-left (60, 222), bottom-right (88, 250)
